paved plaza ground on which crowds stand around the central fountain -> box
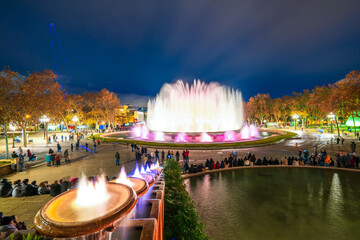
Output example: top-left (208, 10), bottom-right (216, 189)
top-left (0, 131), bottom-right (358, 227)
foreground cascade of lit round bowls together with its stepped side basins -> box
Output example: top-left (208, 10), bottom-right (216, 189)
top-left (34, 163), bottom-right (165, 240)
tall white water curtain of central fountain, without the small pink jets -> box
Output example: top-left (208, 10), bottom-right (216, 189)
top-left (147, 80), bottom-right (243, 133)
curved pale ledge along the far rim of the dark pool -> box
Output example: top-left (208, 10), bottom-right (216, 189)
top-left (182, 165), bottom-right (360, 178)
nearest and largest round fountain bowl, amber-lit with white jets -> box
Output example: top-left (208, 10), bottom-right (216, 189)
top-left (34, 173), bottom-right (137, 238)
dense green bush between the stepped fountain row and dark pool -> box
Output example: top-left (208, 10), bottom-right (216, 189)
top-left (164, 159), bottom-right (209, 240)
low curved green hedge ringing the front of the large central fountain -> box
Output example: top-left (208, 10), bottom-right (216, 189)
top-left (94, 131), bottom-right (297, 149)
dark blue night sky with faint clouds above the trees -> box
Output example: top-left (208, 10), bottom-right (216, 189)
top-left (0, 0), bottom-right (360, 104)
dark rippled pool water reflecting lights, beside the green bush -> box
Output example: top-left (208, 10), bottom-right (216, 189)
top-left (185, 168), bottom-right (360, 240)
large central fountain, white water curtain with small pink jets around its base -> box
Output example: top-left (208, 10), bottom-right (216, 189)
top-left (132, 80), bottom-right (260, 143)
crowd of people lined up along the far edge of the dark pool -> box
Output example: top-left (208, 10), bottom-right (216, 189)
top-left (183, 149), bottom-right (360, 173)
